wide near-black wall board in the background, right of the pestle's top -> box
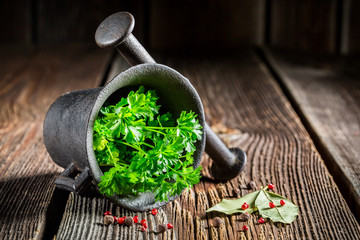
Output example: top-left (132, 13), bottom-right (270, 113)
top-left (149, 0), bottom-right (265, 51)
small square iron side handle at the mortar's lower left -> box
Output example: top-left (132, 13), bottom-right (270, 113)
top-left (55, 163), bottom-right (90, 193)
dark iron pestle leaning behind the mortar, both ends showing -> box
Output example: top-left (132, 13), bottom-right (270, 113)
top-left (95, 12), bottom-right (246, 180)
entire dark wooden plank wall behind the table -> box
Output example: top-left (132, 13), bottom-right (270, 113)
top-left (0, 0), bottom-right (360, 54)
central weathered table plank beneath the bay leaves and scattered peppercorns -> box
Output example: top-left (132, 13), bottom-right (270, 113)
top-left (57, 51), bottom-right (360, 239)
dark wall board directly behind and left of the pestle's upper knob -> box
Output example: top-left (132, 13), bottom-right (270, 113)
top-left (36, 0), bottom-right (124, 43)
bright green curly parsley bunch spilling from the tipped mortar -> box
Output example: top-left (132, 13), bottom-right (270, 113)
top-left (93, 86), bottom-right (202, 201)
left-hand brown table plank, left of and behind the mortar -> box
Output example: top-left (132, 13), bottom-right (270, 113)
top-left (0, 46), bottom-right (109, 239)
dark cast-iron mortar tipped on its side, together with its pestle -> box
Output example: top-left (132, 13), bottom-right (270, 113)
top-left (44, 12), bottom-right (246, 211)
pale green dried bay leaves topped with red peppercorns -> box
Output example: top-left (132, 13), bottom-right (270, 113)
top-left (206, 184), bottom-right (299, 223)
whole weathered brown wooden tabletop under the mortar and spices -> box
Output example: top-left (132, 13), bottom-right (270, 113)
top-left (0, 45), bottom-right (360, 239)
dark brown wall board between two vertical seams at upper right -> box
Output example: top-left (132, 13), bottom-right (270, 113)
top-left (269, 0), bottom-right (337, 52)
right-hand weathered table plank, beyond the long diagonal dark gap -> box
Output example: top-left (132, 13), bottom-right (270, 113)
top-left (267, 48), bottom-right (360, 219)
